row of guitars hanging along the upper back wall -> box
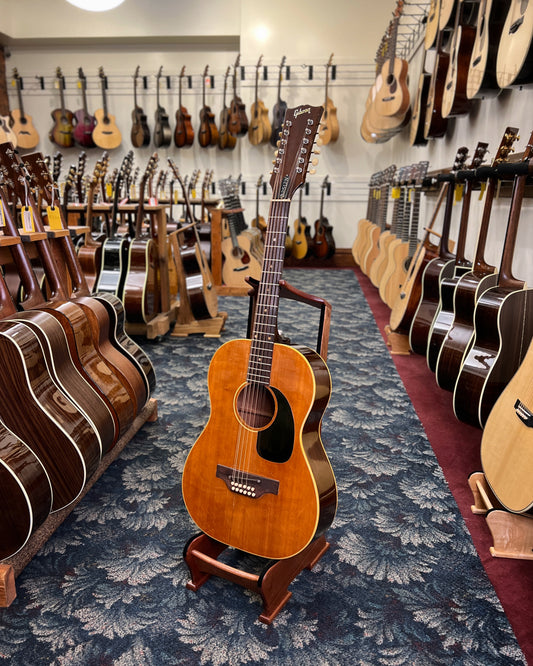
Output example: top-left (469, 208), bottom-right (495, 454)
top-left (0, 54), bottom-right (339, 150)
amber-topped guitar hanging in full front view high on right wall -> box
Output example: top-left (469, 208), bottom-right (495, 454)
top-left (374, 0), bottom-right (410, 118)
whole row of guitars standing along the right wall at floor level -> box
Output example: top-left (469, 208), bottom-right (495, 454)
top-left (353, 127), bottom-right (533, 512)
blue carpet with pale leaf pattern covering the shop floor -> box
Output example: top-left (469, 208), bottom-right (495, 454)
top-left (0, 270), bottom-right (525, 666)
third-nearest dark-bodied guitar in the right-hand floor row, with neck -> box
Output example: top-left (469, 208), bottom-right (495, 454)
top-left (426, 141), bottom-right (488, 372)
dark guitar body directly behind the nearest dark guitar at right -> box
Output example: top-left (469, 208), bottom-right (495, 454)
top-left (435, 271), bottom-right (498, 391)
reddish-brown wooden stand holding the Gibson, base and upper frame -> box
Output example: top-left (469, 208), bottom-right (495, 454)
top-left (183, 278), bottom-right (331, 624)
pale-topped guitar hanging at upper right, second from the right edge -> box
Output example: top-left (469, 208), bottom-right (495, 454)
top-left (466, 0), bottom-right (510, 99)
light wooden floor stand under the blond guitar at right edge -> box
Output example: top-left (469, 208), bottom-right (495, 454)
top-left (468, 472), bottom-right (533, 560)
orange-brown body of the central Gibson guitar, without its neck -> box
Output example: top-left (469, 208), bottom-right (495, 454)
top-left (182, 340), bottom-right (337, 559)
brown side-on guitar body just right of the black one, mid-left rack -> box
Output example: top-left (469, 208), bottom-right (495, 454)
top-left (122, 238), bottom-right (160, 323)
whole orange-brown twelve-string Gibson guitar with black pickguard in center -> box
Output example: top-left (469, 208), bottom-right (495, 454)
top-left (182, 106), bottom-right (337, 559)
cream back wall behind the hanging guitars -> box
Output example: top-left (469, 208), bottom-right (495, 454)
top-left (2, 0), bottom-right (393, 247)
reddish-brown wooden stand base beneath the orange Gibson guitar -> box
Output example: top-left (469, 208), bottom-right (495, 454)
top-left (183, 534), bottom-right (329, 624)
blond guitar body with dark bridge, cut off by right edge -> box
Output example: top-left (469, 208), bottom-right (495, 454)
top-left (481, 334), bottom-right (533, 513)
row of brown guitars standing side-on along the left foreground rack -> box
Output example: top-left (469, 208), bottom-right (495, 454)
top-left (0, 143), bottom-right (155, 559)
